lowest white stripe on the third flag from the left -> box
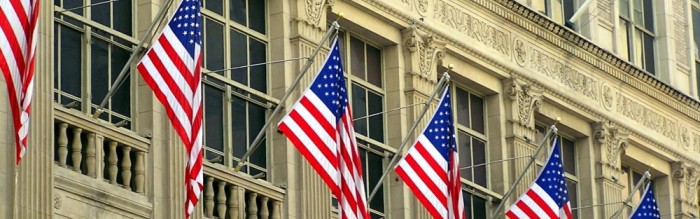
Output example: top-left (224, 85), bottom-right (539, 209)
top-left (282, 116), bottom-right (340, 185)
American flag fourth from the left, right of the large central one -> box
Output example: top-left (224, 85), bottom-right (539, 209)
top-left (395, 87), bottom-right (466, 219)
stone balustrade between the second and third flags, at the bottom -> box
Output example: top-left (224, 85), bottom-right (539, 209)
top-left (202, 162), bottom-right (285, 219)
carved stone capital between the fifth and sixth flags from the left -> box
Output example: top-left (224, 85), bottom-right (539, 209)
top-left (593, 121), bottom-right (629, 170)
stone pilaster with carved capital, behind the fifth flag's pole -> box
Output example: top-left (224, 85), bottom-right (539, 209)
top-left (504, 76), bottom-right (547, 210)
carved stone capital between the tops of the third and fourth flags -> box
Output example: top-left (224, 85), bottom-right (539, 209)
top-left (403, 25), bottom-right (445, 78)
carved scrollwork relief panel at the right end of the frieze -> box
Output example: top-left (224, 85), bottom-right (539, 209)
top-left (616, 93), bottom-right (678, 141)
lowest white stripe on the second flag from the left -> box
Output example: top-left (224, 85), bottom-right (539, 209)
top-left (141, 56), bottom-right (192, 138)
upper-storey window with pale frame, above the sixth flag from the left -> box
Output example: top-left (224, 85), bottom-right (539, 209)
top-left (618, 0), bottom-right (656, 74)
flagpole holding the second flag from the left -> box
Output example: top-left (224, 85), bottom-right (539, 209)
top-left (92, 0), bottom-right (173, 118)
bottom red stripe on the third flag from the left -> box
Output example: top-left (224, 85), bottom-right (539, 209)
top-left (278, 122), bottom-right (340, 197)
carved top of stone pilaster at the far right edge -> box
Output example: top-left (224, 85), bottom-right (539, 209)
top-left (671, 161), bottom-right (700, 219)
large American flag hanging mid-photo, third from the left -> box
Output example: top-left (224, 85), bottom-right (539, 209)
top-left (278, 39), bottom-right (369, 218)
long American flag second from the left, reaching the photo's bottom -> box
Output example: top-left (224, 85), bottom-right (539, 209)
top-left (138, 0), bottom-right (204, 217)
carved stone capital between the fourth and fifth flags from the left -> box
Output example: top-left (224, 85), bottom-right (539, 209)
top-left (505, 77), bottom-right (542, 128)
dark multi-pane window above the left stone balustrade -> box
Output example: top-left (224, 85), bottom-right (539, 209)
top-left (54, 0), bottom-right (137, 128)
